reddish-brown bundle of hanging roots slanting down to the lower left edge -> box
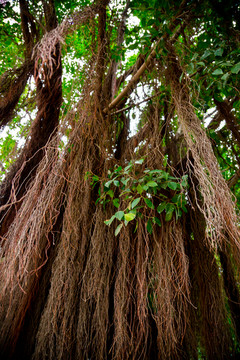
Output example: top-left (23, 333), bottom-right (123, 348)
top-left (0, 136), bottom-right (65, 349)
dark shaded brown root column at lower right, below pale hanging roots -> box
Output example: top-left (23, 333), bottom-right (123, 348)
top-left (188, 191), bottom-right (232, 360)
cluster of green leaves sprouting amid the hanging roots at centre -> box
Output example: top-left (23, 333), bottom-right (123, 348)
top-left (85, 158), bottom-right (188, 235)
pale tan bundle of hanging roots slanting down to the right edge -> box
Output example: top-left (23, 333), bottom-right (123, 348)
top-left (167, 45), bottom-right (240, 255)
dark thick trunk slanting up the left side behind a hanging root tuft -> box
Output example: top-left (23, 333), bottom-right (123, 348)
top-left (0, 2), bottom-right (62, 237)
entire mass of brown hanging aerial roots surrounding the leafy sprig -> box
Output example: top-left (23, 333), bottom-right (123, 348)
top-left (0, 1), bottom-right (240, 360)
